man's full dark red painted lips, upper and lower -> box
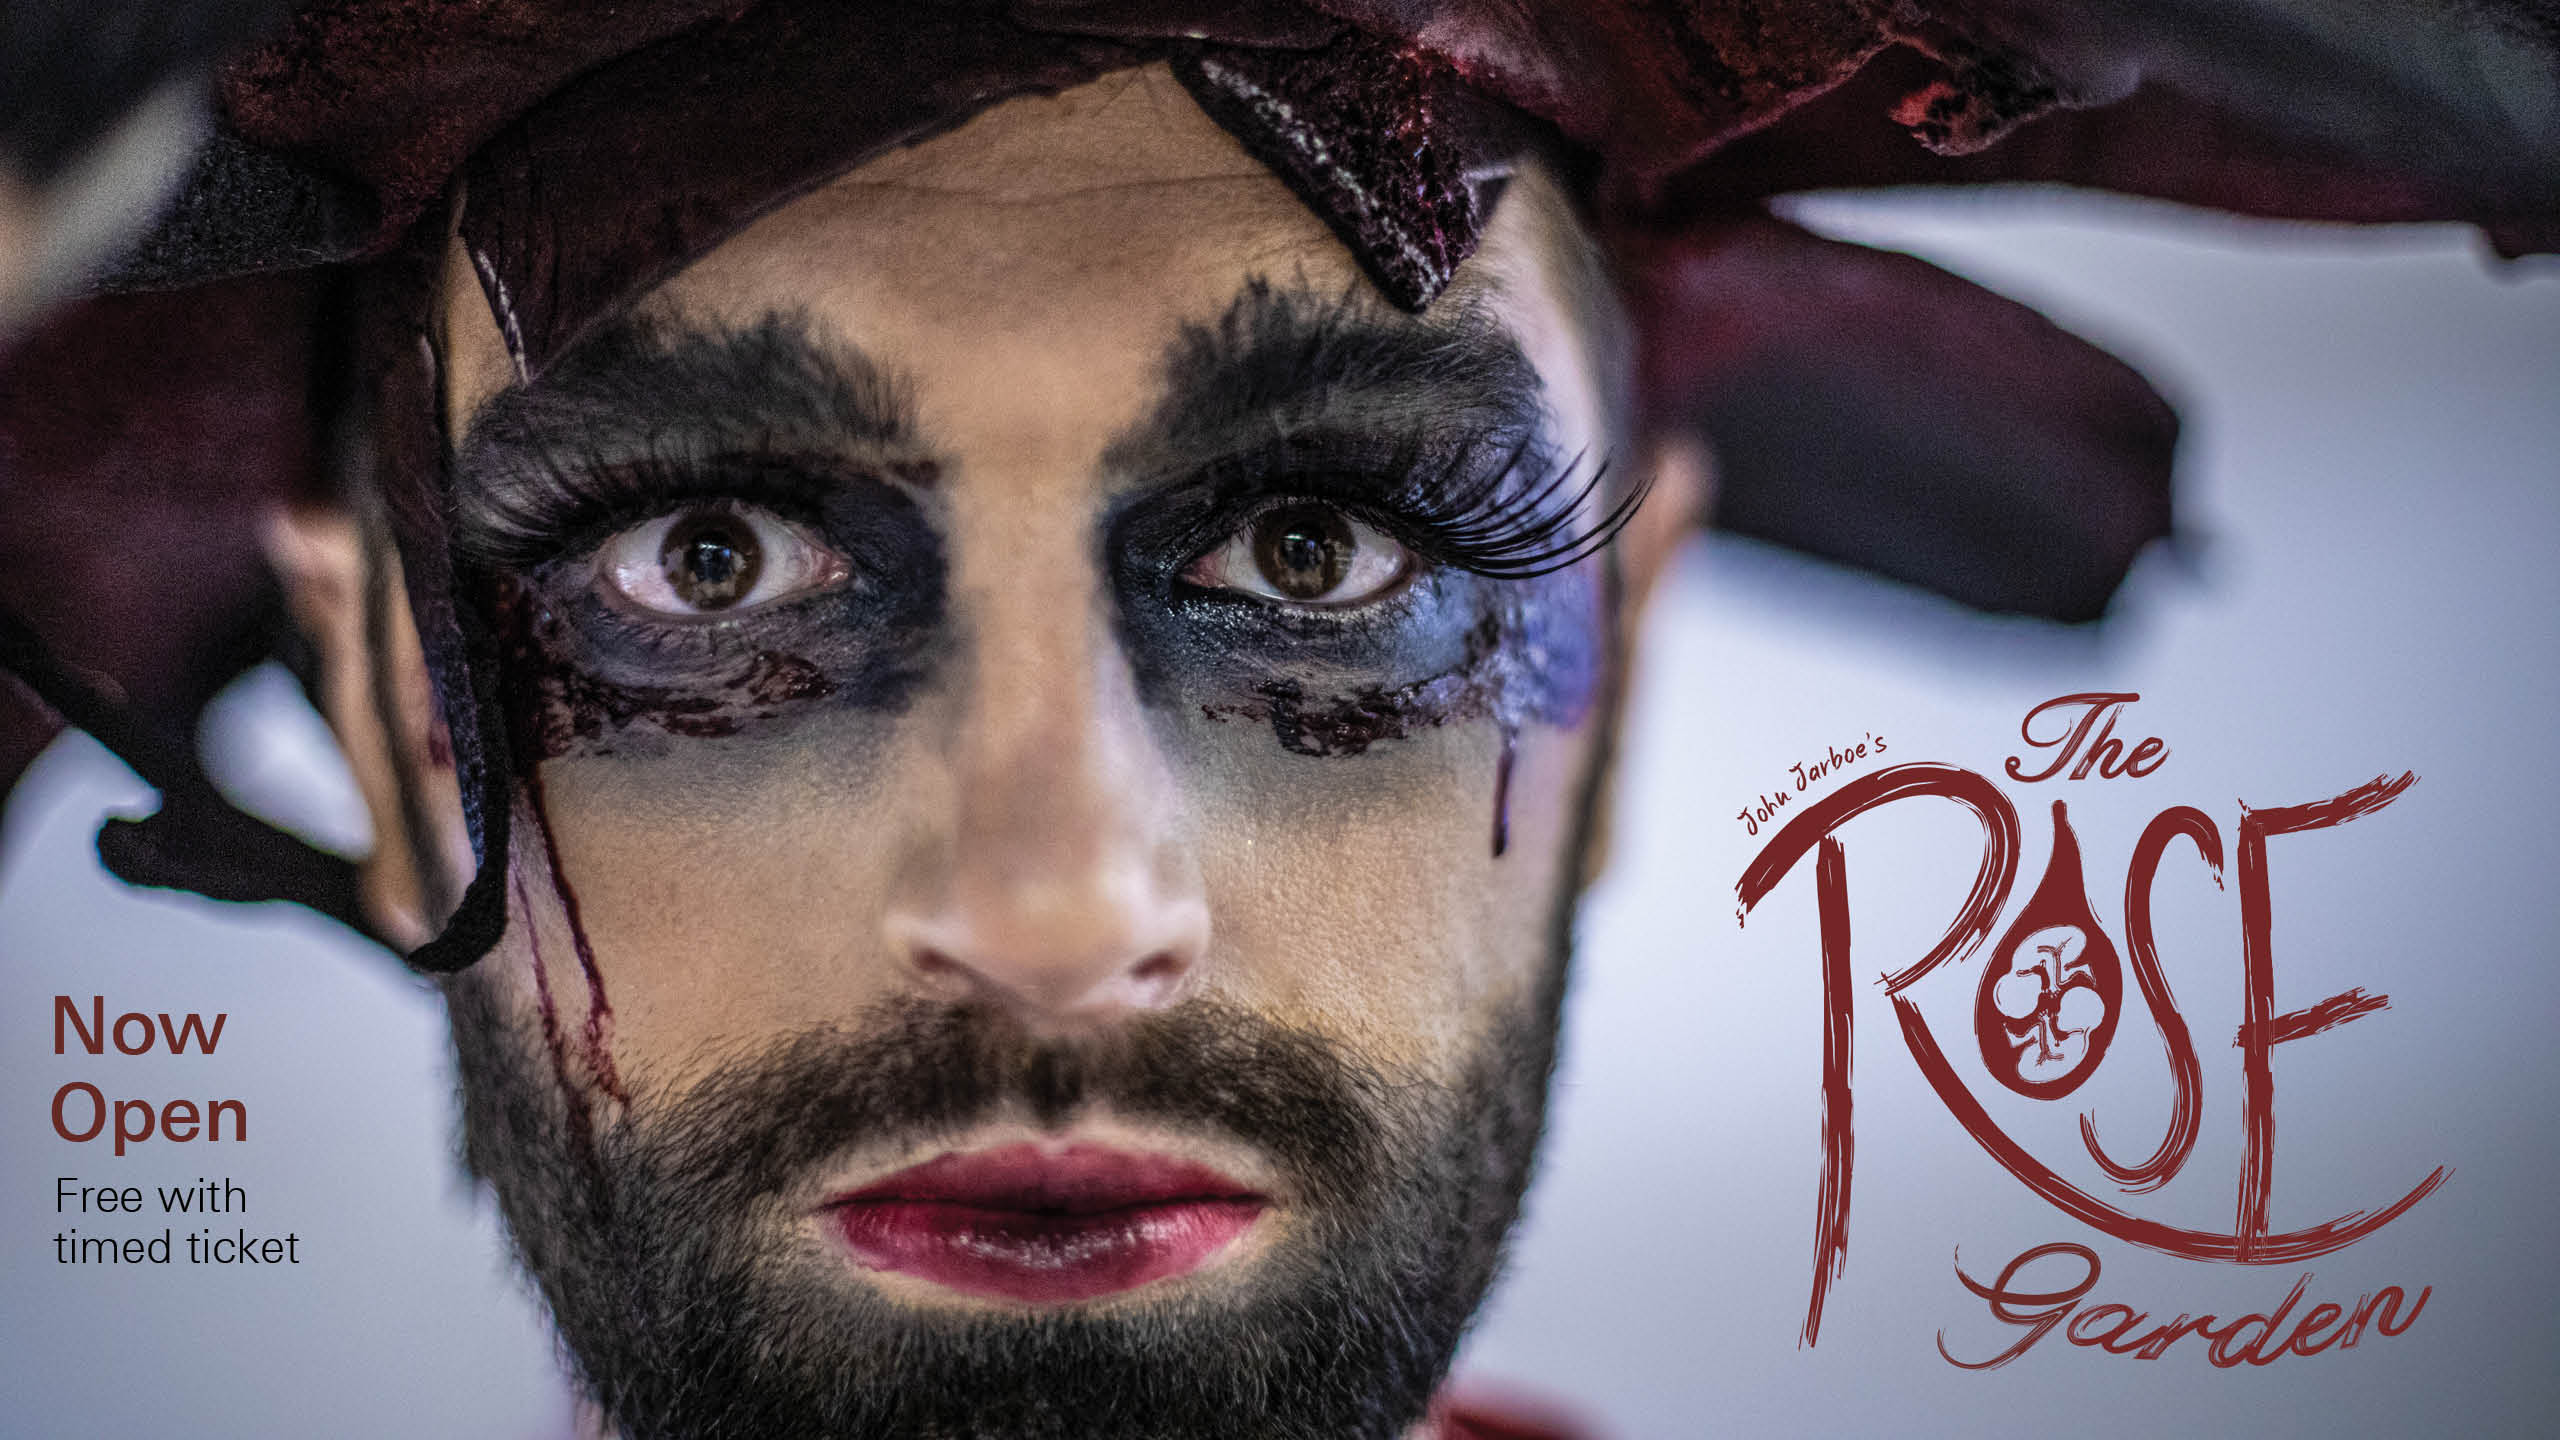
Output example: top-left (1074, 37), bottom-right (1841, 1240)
top-left (827, 1143), bottom-right (1270, 1304)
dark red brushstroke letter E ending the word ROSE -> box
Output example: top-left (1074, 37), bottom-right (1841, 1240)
top-left (2232, 771), bottom-right (2445, 1263)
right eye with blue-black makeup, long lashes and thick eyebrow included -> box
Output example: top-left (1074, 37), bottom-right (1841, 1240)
top-left (1101, 282), bottom-right (1644, 756)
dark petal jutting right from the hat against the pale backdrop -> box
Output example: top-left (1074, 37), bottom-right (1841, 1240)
top-left (1626, 215), bottom-right (2179, 620)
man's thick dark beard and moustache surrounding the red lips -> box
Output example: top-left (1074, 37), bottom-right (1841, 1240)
top-left (451, 968), bottom-right (1564, 1440)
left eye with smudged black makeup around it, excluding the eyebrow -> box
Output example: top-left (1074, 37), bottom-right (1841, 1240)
top-left (460, 446), bottom-right (945, 761)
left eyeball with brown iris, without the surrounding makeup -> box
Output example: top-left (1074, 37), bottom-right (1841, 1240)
top-left (596, 505), bottom-right (845, 620)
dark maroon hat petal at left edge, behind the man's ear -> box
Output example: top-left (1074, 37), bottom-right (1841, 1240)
top-left (0, 277), bottom-right (317, 779)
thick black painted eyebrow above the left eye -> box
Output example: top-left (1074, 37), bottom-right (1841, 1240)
top-left (453, 313), bottom-right (929, 564)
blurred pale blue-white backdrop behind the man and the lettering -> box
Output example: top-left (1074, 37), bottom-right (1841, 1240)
top-left (0, 195), bottom-right (2560, 1440)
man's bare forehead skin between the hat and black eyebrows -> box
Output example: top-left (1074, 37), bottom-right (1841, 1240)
top-left (445, 67), bottom-right (1592, 464)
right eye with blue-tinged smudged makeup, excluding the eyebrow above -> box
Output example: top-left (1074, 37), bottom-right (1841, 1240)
top-left (1103, 433), bottom-right (1605, 756)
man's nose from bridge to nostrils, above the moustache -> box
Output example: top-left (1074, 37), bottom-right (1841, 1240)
top-left (886, 576), bottom-right (1208, 1030)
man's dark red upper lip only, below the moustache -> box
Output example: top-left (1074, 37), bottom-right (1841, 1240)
top-left (827, 1140), bottom-right (1262, 1215)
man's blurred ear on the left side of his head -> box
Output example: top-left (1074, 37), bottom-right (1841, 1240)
top-left (266, 505), bottom-right (471, 951)
